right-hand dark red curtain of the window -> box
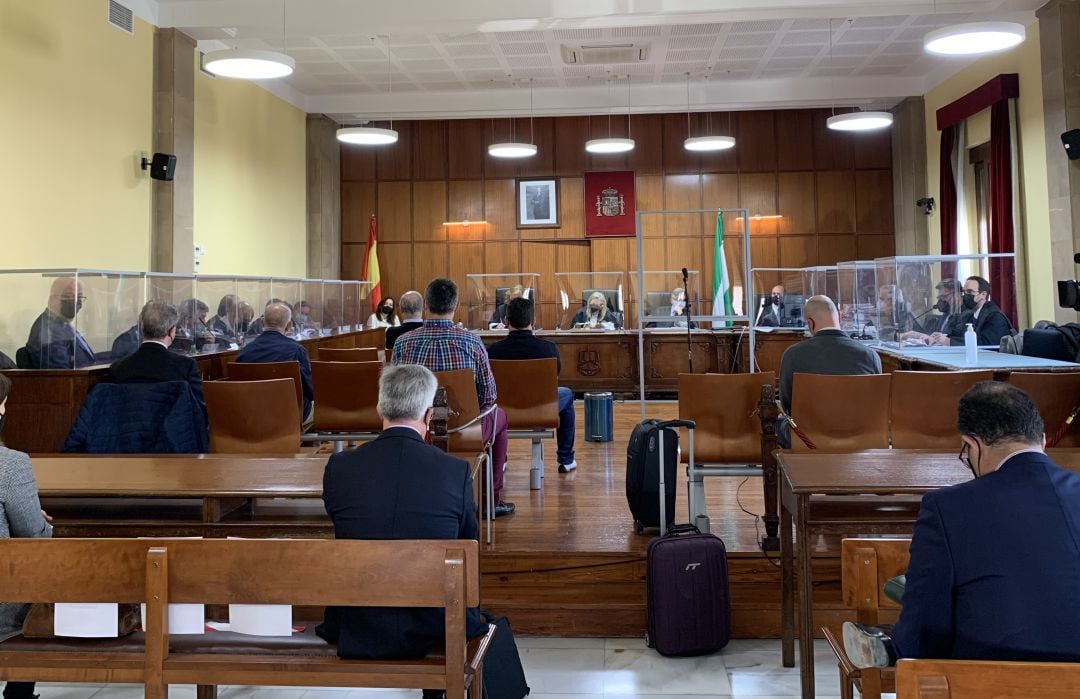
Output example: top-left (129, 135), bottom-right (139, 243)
top-left (989, 99), bottom-right (1016, 327)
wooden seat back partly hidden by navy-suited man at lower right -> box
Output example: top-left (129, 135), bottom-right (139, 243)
top-left (840, 539), bottom-right (912, 623)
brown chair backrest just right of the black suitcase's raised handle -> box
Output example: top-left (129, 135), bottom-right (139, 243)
top-left (678, 372), bottom-right (777, 463)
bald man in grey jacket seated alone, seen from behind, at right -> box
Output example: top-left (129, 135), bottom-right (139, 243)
top-left (778, 296), bottom-right (881, 447)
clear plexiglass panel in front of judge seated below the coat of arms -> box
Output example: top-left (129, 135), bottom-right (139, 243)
top-left (555, 272), bottom-right (627, 331)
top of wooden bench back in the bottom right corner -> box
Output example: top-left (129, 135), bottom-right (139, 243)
top-left (896, 659), bottom-right (1080, 699)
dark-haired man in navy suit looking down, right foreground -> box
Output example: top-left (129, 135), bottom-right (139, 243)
top-left (843, 381), bottom-right (1080, 668)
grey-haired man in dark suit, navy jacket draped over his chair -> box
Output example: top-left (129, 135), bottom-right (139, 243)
top-left (106, 301), bottom-right (206, 414)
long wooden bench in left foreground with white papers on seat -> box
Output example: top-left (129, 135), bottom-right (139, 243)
top-left (0, 539), bottom-right (495, 699)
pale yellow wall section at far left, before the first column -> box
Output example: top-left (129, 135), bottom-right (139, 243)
top-left (0, 0), bottom-right (153, 271)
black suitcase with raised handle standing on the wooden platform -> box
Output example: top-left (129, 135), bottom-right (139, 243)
top-left (626, 419), bottom-right (696, 535)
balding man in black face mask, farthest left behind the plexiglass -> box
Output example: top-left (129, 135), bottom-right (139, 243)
top-left (26, 277), bottom-right (95, 368)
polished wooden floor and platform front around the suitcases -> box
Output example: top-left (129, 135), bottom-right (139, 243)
top-left (481, 401), bottom-right (849, 637)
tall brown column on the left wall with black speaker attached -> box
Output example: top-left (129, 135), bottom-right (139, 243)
top-left (150, 29), bottom-right (195, 272)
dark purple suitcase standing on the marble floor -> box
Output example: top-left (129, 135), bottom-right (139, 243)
top-left (645, 524), bottom-right (731, 656)
